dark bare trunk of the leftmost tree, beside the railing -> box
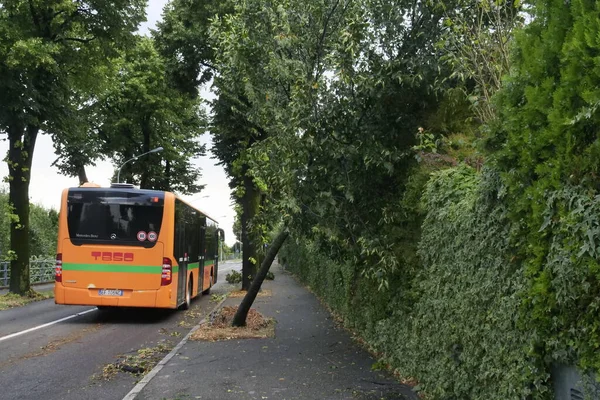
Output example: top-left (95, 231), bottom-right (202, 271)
top-left (8, 124), bottom-right (39, 295)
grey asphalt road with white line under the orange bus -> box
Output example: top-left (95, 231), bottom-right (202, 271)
top-left (0, 262), bottom-right (241, 400)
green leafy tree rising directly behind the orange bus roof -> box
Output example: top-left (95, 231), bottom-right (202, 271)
top-left (51, 36), bottom-right (206, 193)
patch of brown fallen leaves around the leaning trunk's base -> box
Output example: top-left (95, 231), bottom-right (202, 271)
top-left (190, 306), bottom-right (275, 342)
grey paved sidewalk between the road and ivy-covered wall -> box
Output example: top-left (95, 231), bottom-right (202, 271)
top-left (136, 265), bottom-right (417, 400)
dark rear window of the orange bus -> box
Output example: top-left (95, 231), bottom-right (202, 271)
top-left (67, 189), bottom-right (164, 247)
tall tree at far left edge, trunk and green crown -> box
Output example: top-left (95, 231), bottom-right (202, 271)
top-left (0, 0), bottom-right (145, 294)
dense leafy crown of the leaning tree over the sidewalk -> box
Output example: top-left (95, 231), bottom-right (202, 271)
top-left (213, 1), bottom-right (445, 284)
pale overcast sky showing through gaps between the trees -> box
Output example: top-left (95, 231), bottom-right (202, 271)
top-left (0, 0), bottom-right (236, 245)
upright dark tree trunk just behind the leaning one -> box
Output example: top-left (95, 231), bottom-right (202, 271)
top-left (241, 167), bottom-right (260, 290)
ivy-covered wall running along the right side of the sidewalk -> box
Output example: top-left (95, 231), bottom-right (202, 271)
top-left (280, 166), bottom-right (600, 400)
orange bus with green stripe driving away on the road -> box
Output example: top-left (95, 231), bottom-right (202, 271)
top-left (54, 184), bottom-right (224, 309)
